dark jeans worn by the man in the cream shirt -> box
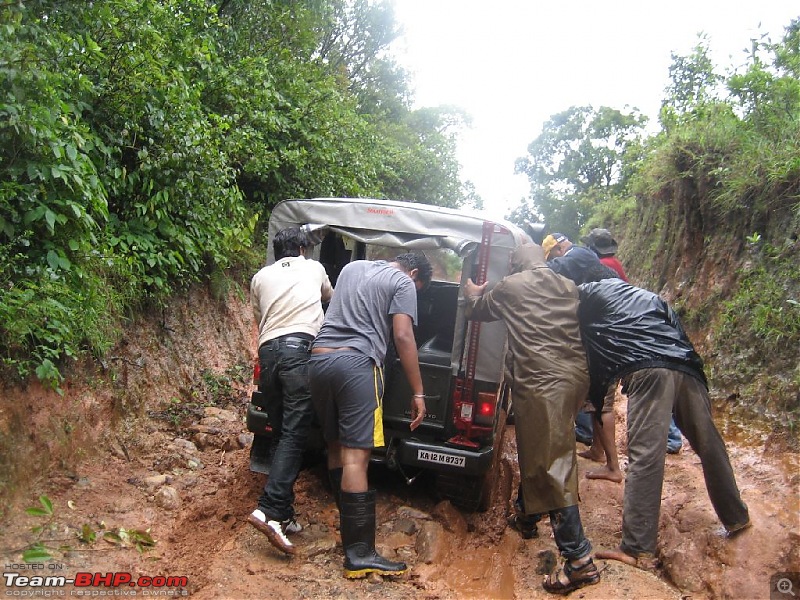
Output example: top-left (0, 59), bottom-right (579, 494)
top-left (258, 336), bottom-right (314, 521)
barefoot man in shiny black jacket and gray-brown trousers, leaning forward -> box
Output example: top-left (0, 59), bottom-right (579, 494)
top-left (579, 279), bottom-right (750, 565)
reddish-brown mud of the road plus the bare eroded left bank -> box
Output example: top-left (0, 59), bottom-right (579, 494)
top-left (0, 288), bottom-right (800, 600)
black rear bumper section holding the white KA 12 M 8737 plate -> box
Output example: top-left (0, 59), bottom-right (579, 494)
top-left (396, 439), bottom-right (494, 476)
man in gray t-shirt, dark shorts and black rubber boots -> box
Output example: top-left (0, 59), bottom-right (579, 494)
top-left (309, 254), bottom-right (431, 578)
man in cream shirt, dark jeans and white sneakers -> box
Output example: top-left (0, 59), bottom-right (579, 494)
top-left (248, 227), bottom-right (333, 554)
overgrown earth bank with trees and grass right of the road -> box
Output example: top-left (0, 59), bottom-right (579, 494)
top-left (512, 20), bottom-right (800, 426)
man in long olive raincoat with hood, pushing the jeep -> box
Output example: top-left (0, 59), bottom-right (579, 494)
top-left (465, 244), bottom-right (600, 594)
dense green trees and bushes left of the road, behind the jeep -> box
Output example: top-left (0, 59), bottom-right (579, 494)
top-left (0, 0), bottom-right (463, 387)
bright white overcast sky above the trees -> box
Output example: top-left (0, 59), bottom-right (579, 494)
top-left (394, 0), bottom-right (800, 216)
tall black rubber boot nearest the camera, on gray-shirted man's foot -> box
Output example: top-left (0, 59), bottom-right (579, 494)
top-left (340, 490), bottom-right (408, 579)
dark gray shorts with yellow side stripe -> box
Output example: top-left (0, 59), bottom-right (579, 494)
top-left (308, 350), bottom-right (385, 449)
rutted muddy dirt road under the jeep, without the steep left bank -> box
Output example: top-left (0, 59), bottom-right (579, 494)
top-left (0, 392), bottom-right (800, 600)
